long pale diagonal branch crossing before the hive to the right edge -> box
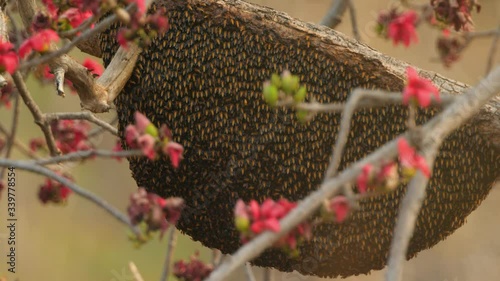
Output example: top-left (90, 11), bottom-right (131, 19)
top-left (207, 67), bottom-right (500, 281)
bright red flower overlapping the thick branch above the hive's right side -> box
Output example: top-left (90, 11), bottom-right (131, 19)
top-left (403, 67), bottom-right (440, 108)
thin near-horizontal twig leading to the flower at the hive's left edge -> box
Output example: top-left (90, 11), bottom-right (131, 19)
top-left (32, 150), bottom-right (144, 166)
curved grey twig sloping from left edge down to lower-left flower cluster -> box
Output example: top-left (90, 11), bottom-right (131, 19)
top-left (0, 159), bottom-right (141, 237)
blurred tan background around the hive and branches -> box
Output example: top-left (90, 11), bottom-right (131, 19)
top-left (0, 0), bottom-right (500, 281)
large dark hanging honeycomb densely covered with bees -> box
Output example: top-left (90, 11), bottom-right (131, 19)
top-left (101, 1), bottom-right (500, 276)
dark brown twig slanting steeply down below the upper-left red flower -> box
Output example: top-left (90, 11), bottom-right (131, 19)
top-left (12, 71), bottom-right (59, 156)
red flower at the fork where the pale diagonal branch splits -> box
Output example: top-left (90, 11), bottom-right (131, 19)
top-left (398, 138), bottom-right (431, 178)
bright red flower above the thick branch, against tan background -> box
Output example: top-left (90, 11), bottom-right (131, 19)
top-left (387, 11), bottom-right (418, 47)
